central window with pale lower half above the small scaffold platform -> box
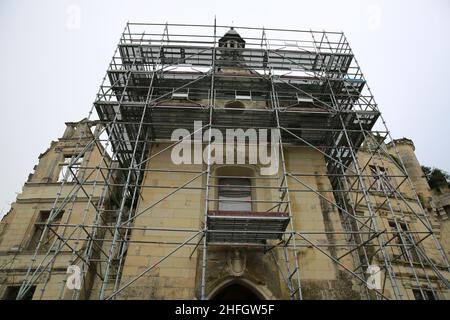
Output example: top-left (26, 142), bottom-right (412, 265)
top-left (219, 178), bottom-right (252, 211)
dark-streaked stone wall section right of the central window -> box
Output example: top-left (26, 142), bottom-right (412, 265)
top-left (285, 147), bottom-right (361, 299)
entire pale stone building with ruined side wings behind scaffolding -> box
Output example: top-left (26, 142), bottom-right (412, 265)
top-left (0, 28), bottom-right (450, 300)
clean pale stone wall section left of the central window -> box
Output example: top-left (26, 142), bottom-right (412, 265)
top-left (120, 144), bottom-right (204, 299)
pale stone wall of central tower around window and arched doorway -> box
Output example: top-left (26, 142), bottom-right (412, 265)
top-left (120, 144), bottom-right (360, 299)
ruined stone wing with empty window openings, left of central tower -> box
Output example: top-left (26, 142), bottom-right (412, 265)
top-left (0, 120), bottom-right (118, 299)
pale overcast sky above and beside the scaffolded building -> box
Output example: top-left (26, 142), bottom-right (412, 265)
top-left (0, 0), bottom-right (450, 216)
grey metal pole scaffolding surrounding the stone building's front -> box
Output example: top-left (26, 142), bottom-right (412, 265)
top-left (14, 22), bottom-right (450, 299)
